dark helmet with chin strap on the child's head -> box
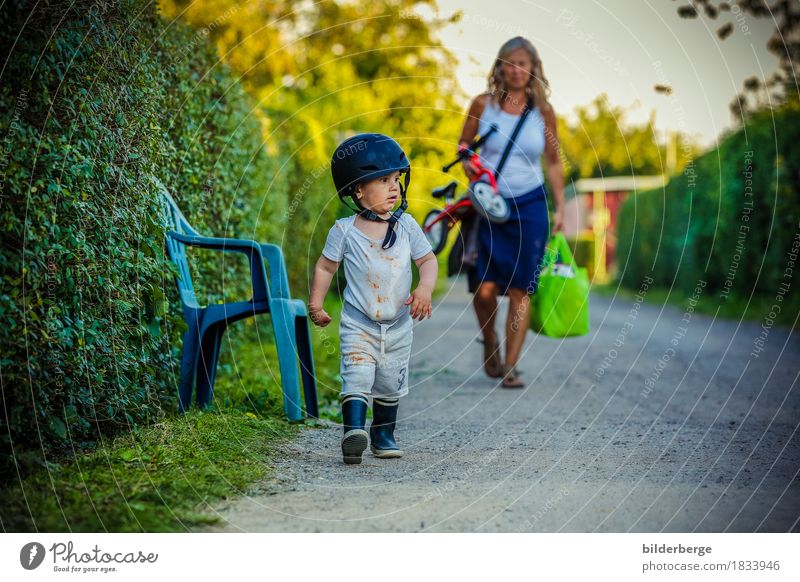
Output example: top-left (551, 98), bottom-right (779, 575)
top-left (331, 133), bottom-right (411, 249)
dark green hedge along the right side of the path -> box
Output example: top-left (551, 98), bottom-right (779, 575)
top-left (617, 103), bottom-right (800, 298)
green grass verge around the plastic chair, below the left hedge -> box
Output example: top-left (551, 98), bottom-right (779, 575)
top-left (0, 298), bottom-right (341, 532)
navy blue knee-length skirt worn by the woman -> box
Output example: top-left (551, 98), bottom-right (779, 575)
top-left (475, 185), bottom-right (550, 295)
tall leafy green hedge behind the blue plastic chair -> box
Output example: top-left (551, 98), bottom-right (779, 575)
top-left (0, 0), bottom-right (278, 469)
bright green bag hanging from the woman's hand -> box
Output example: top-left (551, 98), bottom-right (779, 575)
top-left (530, 232), bottom-right (591, 337)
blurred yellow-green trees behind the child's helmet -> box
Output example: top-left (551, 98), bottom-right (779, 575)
top-left (160, 0), bottom-right (464, 294)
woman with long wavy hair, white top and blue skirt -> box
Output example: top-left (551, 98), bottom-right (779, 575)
top-left (459, 37), bottom-right (564, 388)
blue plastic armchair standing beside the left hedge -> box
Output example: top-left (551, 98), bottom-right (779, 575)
top-left (154, 178), bottom-right (319, 421)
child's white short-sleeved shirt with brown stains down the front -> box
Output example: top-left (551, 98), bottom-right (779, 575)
top-left (322, 214), bottom-right (432, 321)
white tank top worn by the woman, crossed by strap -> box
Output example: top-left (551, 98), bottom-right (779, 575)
top-left (478, 98), bottom-right (545, 198)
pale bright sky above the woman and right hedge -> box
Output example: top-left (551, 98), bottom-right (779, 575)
top-left (420, 0), bottom-right (778, 146)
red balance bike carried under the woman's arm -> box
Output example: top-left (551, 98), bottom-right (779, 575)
top-left (422, 125), bottom-right (511, 255)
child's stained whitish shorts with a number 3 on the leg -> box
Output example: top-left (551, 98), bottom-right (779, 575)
top-left (339, 303), bottom-right (414, 399)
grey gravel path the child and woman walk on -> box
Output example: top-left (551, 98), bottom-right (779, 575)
top-left (202, 280), bottom-right (800, 532)
